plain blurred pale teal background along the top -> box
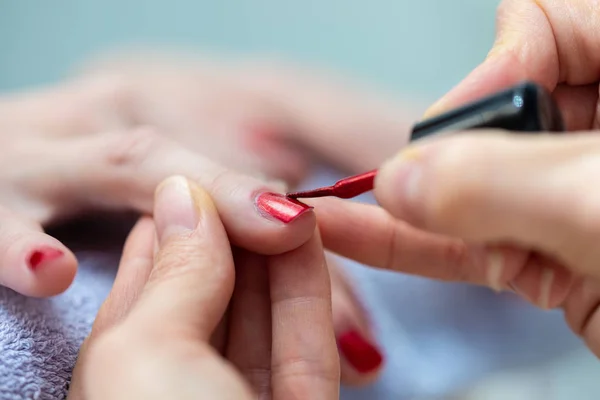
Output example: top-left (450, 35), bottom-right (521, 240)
top-left (0, 0), bottom-right (497, 100)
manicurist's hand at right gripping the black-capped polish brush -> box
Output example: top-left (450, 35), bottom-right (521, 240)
top-left (318, 1), bottom-right (600, 355)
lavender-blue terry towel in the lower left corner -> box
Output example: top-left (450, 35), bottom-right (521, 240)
top-left (0, 253), bottom-right (116, 400)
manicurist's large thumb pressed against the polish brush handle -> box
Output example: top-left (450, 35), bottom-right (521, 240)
top-left (375, 132), bottom-right (600, 277)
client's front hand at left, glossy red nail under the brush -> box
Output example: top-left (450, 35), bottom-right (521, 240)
top-left (0, 122), bottom-right (316, 296)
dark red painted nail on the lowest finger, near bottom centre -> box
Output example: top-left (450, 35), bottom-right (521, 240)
top-left (338, 331), bottom-right (383, 374)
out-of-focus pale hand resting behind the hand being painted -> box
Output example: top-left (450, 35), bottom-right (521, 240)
top-left (0, 53), bottom-right (417, 185)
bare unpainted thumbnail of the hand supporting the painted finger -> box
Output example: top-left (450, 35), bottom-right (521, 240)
top-left (154, 176), bottom-right (199, 243)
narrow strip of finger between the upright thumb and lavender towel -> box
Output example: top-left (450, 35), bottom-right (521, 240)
top-left (68, 218), bottom-right (154, 400)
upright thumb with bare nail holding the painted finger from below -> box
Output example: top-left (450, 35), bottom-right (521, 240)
top-left (78, 176), bottom-right (249, 399)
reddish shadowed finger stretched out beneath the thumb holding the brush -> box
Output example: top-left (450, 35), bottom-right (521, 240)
top-left (318, 199), bottom-right (572, 308)
